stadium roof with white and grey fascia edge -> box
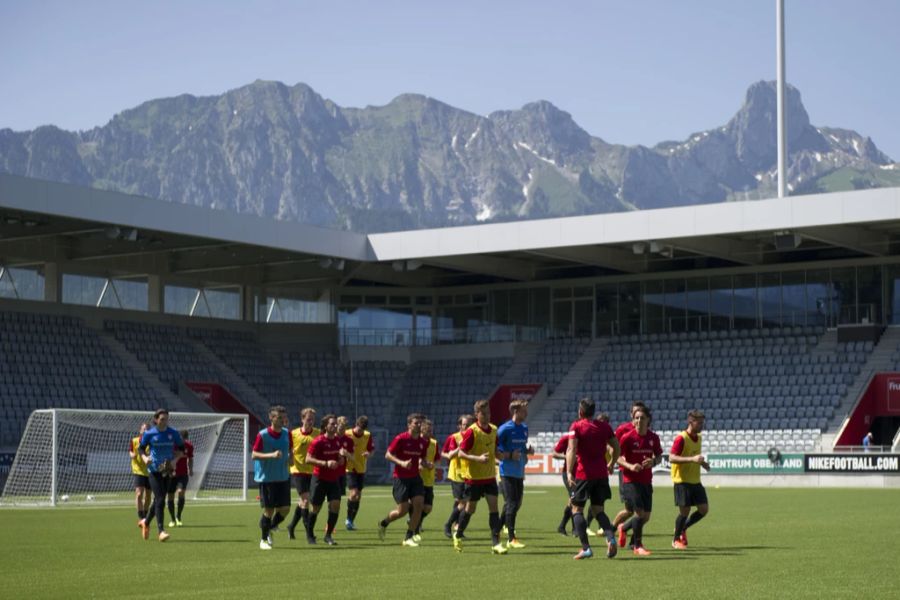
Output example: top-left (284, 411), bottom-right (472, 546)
top-left (0, 174), bottom-right (900, 288)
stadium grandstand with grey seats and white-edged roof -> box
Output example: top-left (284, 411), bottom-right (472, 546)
top-left (0, 174), bottom-right (900, 482)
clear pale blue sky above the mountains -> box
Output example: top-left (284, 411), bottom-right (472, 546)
top-left (0, 0), bottom-right (900, 160)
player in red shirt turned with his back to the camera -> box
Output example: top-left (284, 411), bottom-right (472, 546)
top-left (566, 398), bottom-right (619, 560)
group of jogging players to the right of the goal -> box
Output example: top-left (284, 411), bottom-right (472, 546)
top-left (250, 399), bottom-right (709, 560)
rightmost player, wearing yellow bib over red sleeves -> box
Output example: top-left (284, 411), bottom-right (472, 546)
top-left (669, 409), bottom-right (709, 550)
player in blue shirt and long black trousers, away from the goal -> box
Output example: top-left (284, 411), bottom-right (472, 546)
top-left (497, 400), bottom-right (534, 548)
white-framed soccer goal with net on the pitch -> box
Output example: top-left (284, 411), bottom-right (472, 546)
top-left (0, 408), bottom-right (249, 506)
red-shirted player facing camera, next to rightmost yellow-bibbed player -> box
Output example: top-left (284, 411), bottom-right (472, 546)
top-left (616, 406), bottom-right (662, 556)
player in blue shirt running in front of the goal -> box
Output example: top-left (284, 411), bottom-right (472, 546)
top-left (138, 408), bottom-right (184, 542)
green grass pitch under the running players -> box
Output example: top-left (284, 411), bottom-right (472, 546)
top-left (0, 487), bottom-right (900, 600)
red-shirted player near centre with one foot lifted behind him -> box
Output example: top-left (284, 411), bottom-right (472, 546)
top-left (378, 413), bottom-right (434, 548)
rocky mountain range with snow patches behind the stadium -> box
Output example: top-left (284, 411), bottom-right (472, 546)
top-left (0, 81), bottom-right (900, 233)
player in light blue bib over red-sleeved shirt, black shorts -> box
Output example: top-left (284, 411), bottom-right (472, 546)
top-left (252, 406), bottom-right (291, 550)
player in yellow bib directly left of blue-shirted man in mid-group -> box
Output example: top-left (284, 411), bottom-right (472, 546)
top-left (453, 400), bottom-right (509, 554)
